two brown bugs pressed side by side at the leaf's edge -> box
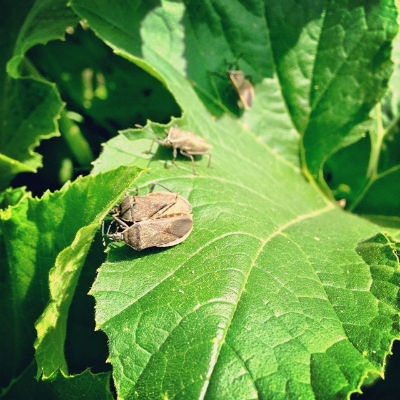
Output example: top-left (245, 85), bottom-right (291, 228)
top-left (103, 185), bottom-right (193, 250)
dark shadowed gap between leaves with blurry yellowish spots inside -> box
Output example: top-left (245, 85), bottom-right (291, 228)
top-left (28, 26), bottom-right (180, 134)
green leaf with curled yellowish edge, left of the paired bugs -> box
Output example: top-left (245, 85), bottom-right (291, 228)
top-left (0, 167), bottom-right (138, 385)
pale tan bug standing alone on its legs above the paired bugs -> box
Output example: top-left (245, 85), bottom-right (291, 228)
top-left (149, 125), bottom-right (212, 174)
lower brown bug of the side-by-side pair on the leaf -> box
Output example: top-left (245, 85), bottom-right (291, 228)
top-left (107, 213), bottom-right (193, 250)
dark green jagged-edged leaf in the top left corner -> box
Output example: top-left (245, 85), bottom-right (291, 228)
top-left (0, 0), bottom-right (76, 190)
